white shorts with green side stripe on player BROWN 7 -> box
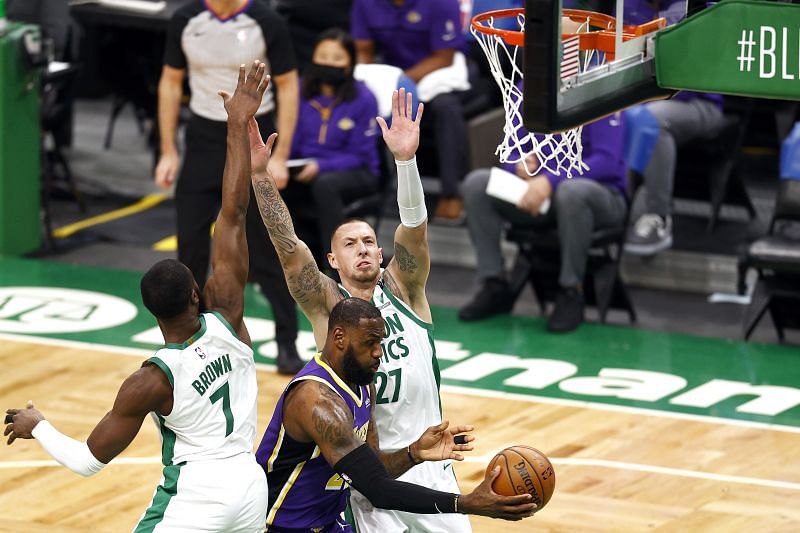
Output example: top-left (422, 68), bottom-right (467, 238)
top-left (134, 453), bottom-right (267, 533)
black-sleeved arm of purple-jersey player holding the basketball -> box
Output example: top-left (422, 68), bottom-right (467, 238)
top-left (283, 381), bottom-right (536, 520)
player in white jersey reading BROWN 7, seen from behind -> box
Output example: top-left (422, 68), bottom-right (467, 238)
top-left (5, 61), bottom-right (276, 532)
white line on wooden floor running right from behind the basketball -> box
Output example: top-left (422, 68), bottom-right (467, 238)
top-left (464, 455), bottom-right (800, 490)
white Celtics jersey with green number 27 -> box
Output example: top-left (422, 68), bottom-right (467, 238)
top-left (342, 282), bottom-right (442, 451)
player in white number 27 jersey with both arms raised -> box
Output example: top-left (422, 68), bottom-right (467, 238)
top-left (250, 89), bottom-right (471, 533)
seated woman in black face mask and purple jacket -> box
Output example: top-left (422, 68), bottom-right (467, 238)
top-left (292, 29), bottom-right (380, 258)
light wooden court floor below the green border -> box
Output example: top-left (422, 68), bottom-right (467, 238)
top-left (0, 341), bottom-right (800, 533)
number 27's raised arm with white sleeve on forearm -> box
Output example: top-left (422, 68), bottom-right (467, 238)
top-left (378, 89), bottom-right (431, 322)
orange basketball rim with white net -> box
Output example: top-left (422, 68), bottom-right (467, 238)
top-left (471, 8), bottom-right (666, 178)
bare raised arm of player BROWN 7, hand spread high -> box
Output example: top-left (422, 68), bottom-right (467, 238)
top-left (204, 61), bottom-right (275, 342)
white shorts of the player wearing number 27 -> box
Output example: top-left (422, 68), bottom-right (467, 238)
top-left (350, 461), bottom-right (472, 533)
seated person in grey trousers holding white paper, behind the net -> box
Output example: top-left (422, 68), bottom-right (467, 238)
top-left (458, 113), bottom-right (627, 331)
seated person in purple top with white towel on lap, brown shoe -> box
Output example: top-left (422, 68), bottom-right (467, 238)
top-left (351, 0), bottom-right (470, 220)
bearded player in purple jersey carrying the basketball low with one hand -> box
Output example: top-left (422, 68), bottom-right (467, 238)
top-left (257, 298), bottom-right (536, 533)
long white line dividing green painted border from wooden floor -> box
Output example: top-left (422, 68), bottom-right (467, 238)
top-left (0, 333), bottom-right (800, 434)
